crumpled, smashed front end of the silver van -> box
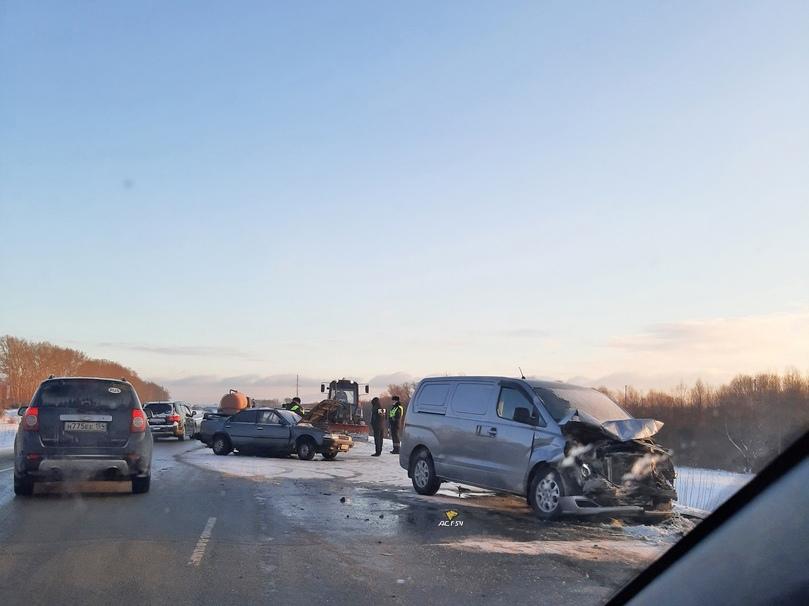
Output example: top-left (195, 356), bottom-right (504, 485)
top-left (558, 411), bottom-right (677, 516)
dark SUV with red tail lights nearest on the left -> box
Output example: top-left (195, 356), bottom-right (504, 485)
top-left (14, 377), bottom-right (153, 496)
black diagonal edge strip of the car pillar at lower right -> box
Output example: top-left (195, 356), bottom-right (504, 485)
top-left (607, 432), bottom-right (809, 606)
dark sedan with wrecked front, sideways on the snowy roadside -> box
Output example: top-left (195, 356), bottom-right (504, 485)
top-left (199, 408), bottom-right (354, 461)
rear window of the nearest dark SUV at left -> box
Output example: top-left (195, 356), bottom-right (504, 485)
top-left (31, 379), bottom-right (137, 410)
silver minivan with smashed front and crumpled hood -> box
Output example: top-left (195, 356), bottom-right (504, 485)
top-left (399, 377), bottom-right (677, 518)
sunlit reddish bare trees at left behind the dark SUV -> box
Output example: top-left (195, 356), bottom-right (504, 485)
top-left (0, 335), bottom-right (169, 408)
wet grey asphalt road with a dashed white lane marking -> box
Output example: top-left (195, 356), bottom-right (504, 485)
top-left (0, 441), bottom-right (660, 606)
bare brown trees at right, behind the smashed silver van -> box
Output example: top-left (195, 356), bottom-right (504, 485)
top-left (600, 370), bottom-right (809, 472)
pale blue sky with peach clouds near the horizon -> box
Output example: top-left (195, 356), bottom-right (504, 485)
top-left (0, 1), bottom-right (809, 401)
